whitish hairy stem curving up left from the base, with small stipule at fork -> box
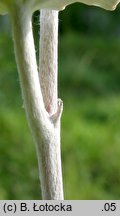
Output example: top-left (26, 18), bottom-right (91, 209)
top-left (9, 3), bottom-right (63, 200)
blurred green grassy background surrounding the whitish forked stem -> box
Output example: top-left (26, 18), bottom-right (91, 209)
top-left (0, 4), bottom-right (120, 200)
